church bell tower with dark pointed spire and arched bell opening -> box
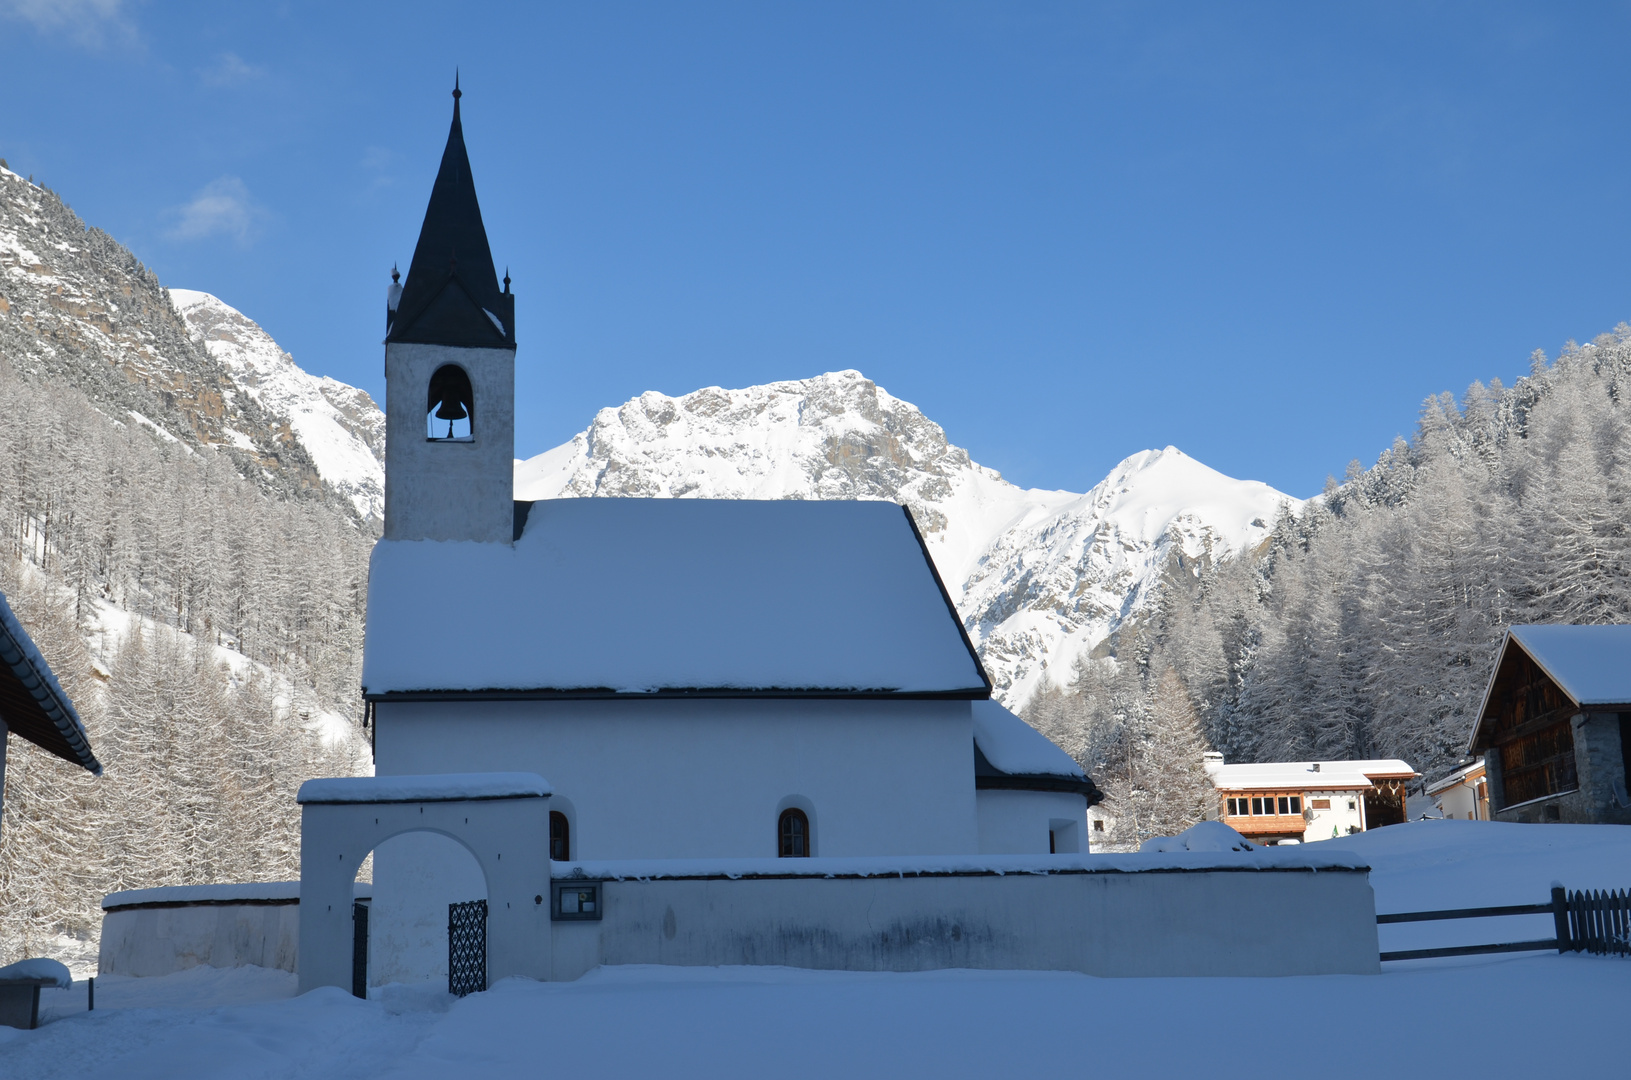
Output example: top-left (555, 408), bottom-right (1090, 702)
top-left (385, 78), bottom-right (515, 543)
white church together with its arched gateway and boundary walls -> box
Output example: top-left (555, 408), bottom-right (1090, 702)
top-left (101, 86), bottom-right (1378, 995)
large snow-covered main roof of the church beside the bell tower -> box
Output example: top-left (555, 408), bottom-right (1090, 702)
top-left (362, 499), bottom-right (988, 698)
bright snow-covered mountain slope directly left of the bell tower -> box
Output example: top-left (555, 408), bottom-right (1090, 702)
top-left (170, 289), bottom-right (385, 519)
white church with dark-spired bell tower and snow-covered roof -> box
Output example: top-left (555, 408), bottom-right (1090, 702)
top-left (349, 80), bottom-right (1099, 984)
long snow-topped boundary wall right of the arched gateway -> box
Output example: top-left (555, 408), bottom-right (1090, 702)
top-left (551, 852), bottom-right (1380, 980)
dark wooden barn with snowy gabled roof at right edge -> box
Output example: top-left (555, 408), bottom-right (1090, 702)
top-left (1468, 625), bottom-right (1631, 824)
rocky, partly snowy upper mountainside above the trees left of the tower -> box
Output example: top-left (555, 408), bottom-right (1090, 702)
top-left (0, 161), bottom-right (378, 520)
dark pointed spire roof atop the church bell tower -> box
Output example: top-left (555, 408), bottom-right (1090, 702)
top-left (385, 77), bottom-right (515, 349)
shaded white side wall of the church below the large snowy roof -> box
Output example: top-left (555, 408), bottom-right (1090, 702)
top-left (375, 698), bottom-right (972, 860)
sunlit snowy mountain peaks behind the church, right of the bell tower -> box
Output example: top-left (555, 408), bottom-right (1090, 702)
top-left (515, 370), bottom-right (1293, 706)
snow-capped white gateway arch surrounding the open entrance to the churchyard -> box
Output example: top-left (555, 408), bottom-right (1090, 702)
top-left (297, 773), bottom-right (550, 994)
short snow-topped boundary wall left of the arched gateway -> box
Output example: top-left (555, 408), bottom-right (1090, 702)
top-left (96, 881), bottom-right (370, 976)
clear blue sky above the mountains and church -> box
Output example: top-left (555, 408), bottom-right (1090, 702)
top-left (0, 0), bottom-right (1631, 494)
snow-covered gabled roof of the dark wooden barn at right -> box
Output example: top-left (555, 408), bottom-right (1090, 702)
top-left (1466, 623), bottom-right (1631, 754)
